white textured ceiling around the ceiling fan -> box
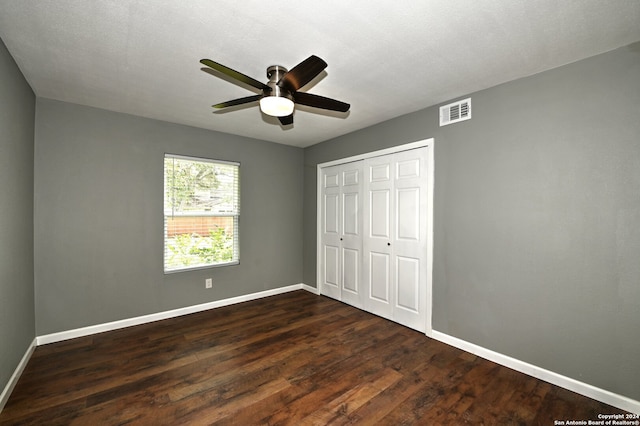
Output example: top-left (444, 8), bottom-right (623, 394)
top-left (0, 0), bottom-right (640, 147)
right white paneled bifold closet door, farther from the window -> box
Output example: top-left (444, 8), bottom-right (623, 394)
top-left (362, 148), bottom-right (427, 331)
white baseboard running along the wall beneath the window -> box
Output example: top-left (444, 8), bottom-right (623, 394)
top-left (36, 284), bottom-right (316, 346)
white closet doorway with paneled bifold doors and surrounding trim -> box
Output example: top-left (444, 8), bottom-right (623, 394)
top-left (317, 139), bottom-right (433, 334)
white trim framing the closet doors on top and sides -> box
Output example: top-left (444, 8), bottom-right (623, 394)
top-left (316, 138), bottom-right (435, 337)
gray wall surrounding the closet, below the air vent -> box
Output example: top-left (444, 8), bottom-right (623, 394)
top-left (304, 43), bottom-right (640, 400)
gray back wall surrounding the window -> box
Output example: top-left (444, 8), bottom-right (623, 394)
top-left (35, 98), bottom-right (303, 335)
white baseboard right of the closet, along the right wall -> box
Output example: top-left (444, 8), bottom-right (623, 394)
top-left (429, 330), bottom-right (640, 414)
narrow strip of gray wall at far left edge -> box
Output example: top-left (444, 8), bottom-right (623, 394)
top-left (0, 41), bottom-right (35, 392)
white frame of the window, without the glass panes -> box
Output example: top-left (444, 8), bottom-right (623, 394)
top-left (162, 153), bottom-right (240, 274)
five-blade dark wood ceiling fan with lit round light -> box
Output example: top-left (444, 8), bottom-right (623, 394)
top-left (200, 55), bottom-right (350, 126)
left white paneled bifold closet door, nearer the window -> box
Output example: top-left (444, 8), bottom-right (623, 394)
top-left (319, 161), bottom-right (364, 308)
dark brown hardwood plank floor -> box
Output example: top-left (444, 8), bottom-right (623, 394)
top-left (0, 291), bottom-right (623, 425)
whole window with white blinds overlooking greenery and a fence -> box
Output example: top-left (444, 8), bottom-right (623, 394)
top-left (164, 154), bottom-right (240, 272)
